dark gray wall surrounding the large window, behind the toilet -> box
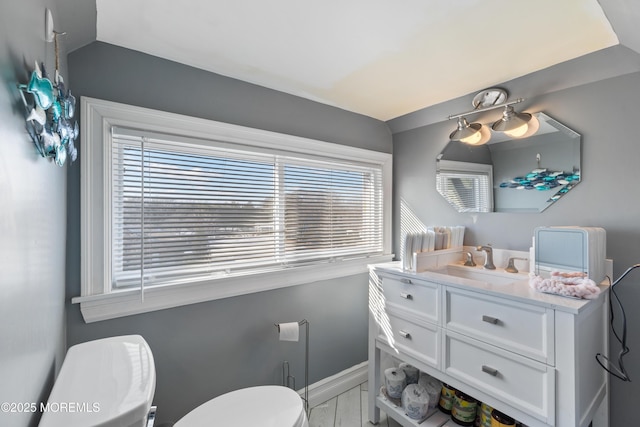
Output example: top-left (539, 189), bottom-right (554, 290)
top-left (67, 42), bottom-right (392, 423)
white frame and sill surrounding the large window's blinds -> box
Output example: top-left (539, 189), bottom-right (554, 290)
top-left (72, 97), bottom-right (393, 323)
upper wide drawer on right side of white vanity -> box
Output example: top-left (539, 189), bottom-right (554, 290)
top-left (444, 288), bottom-right (555, 365)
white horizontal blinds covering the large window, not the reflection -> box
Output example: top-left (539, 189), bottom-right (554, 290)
top-left (111, 127), bottom-right (383, 288)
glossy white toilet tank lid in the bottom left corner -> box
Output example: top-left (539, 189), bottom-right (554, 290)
top-left (40, 335), bottom-right (156, 427)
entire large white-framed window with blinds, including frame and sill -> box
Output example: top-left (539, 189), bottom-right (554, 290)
top-left (74, 98), bottom-right (391, 321)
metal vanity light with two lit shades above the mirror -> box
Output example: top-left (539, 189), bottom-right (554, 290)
top-left (448, 88), bottom-right (539, 145)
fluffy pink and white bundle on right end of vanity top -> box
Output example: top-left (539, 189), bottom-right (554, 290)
top-left (529, 271), bottom-right (600, 299)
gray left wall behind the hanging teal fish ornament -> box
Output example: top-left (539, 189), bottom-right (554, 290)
top-left (0, 0), bottom-right (67, 427)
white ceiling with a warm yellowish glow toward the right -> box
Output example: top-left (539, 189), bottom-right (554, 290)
top-left (96, 0), bottom-right (618, 121)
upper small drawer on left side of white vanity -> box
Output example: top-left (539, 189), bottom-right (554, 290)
top-left (382, 276), bottom-right (440, 323)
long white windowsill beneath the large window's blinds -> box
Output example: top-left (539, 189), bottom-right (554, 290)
top-left (71, 255), bottom-right (393, 323)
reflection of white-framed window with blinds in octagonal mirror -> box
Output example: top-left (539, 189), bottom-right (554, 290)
top-left (436, 160), bottom-right (493, 212)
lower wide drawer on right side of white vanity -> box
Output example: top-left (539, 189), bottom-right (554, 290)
top-left (443, 331), bottom-right (555, 425)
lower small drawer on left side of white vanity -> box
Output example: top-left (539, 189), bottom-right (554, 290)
top-left (378, 312), bottom-right (441, 369)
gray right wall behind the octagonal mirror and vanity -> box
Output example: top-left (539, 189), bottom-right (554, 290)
top-left (394, 72), bottom-right (640, 426)
